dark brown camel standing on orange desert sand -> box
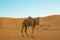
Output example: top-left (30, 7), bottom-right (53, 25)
top-left (21, 17), bottom-right (39, 37)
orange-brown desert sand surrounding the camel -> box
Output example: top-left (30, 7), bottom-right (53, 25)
top-left (0, 15), bottom-right (60, 40)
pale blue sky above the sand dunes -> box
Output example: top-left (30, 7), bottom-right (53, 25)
top-left (0, 0), bottom-right (60, 17)
